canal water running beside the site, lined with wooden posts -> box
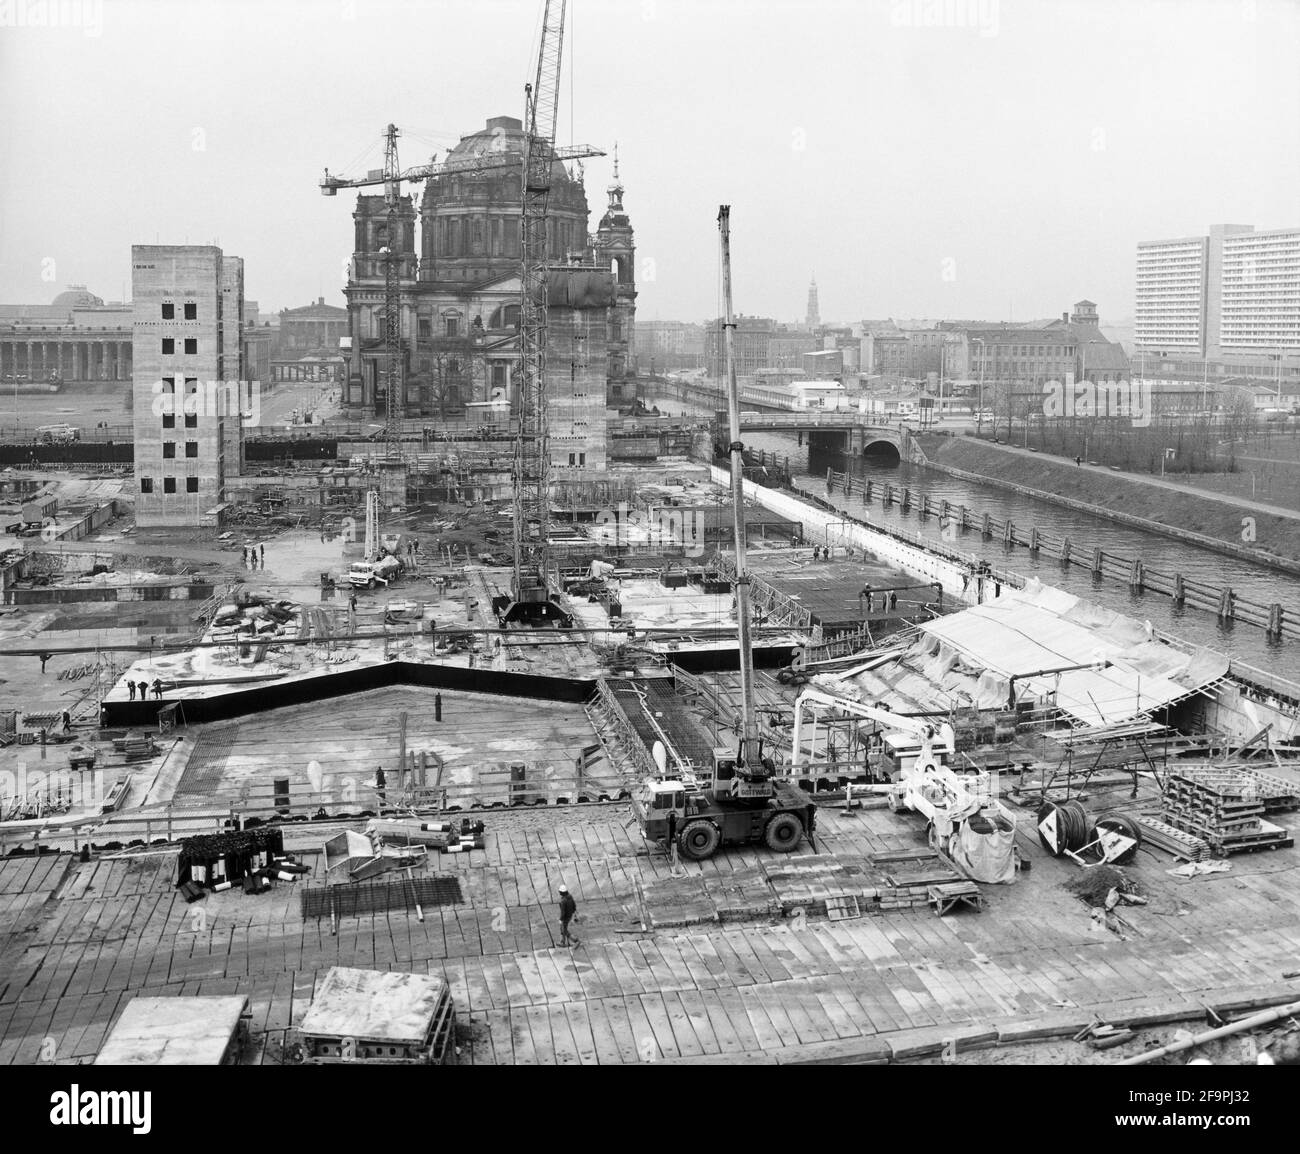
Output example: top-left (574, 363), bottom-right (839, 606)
top-left (745, 433), bottom-right (1300, 681)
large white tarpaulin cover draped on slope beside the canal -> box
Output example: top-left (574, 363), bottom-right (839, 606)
top-left (913, 582), bottom-right (1227, 725)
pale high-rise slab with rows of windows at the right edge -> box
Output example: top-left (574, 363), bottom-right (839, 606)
top-left (1134, 225), bottom-right (1300, 359)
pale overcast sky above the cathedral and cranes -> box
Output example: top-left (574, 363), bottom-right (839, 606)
top-left (0, 0), bottom-right (1300, 321)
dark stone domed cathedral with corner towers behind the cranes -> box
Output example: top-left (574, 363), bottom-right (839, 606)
top-left (343, 117), bottom-right (636, 428)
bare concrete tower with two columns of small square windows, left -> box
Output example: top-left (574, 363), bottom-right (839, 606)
top-left (131, 244), bottom-right (243, 528)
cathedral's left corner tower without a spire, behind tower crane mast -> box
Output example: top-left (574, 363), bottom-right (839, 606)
top-left (343, 196), bottom-right (416, 413)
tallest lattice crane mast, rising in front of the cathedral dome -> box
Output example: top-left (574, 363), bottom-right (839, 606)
top-left (514, 0), bottom-right (566, 600)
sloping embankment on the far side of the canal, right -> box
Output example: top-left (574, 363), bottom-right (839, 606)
top-left (913, 437), bottom-right (1300, 576)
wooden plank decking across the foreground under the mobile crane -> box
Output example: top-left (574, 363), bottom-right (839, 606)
top-left (0, 807), bottom-right (1300, 1064)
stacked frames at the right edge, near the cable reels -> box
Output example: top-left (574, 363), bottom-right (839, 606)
top-left (1162, 768), bottom-right (1295, 860)
